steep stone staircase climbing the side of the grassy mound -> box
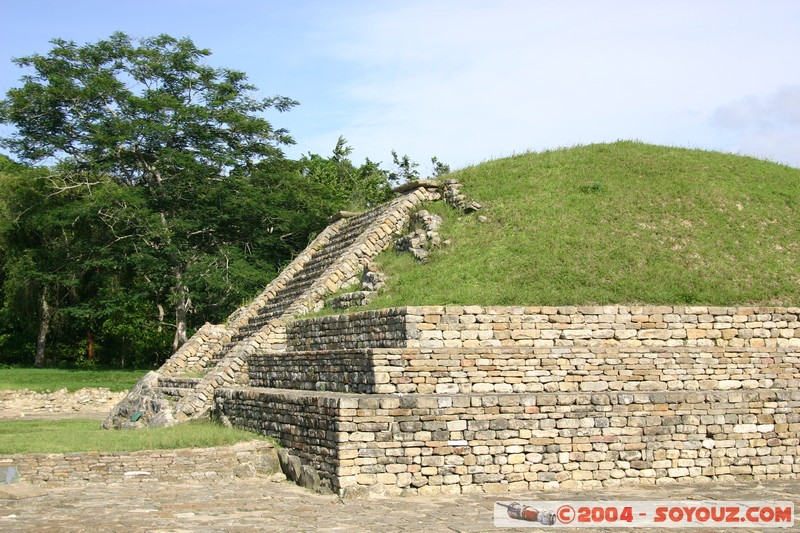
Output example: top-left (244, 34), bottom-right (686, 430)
top-left (104, 180), bottom-right (442, 428)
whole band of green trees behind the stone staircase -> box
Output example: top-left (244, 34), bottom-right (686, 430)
top-left (0, 33), bottom-right (438, 368)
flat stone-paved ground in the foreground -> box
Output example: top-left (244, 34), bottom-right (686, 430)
top-left (0, 478), bottom-right (800, 533)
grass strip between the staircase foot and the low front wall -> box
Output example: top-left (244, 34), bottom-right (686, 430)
top-left (0, 420), bottom-right (263, 455)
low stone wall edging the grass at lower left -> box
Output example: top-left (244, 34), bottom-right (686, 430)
top-left (0, 441), bottom-right (278, 485)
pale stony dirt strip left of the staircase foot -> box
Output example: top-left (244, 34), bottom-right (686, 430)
top-left (0, 388), bottom-right (127, 420)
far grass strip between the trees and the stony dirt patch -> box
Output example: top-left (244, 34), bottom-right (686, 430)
top-left (0, 367), bottom-right (147, 392)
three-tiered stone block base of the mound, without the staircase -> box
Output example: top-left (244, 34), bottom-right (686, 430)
top-left (217, 306), bottom-right (800, 494)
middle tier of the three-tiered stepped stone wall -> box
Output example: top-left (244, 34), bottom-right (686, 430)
top-left (250, 346), bottom-right (800, 394)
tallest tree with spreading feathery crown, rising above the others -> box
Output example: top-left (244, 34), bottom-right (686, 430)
top-left (0, 33), bottom-right (296, 349)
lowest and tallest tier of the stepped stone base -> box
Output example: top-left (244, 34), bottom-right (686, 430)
top-left (218, 389), bottom-right (800, 494)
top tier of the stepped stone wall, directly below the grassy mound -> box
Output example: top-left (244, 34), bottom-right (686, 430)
top-left (288, 305), bottom-right (800, 351)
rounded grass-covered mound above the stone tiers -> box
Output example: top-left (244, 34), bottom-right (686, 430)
top-left (370, 142), bottom-right (800, 308)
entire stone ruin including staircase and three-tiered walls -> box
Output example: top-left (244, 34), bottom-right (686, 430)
top-left (105, 181), bottom-right (800, 496)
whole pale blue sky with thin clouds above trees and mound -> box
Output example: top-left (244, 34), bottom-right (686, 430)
top-left (0, 0), bottom-right (800, 171)
